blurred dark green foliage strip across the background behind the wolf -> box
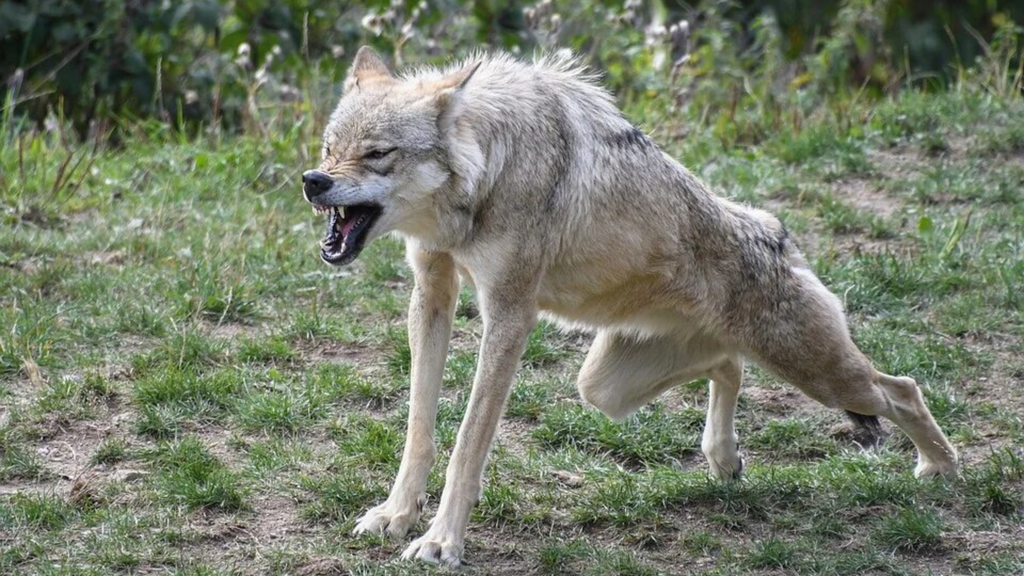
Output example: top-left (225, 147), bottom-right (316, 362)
top-left (0, 0), bottom-right (1024, 137)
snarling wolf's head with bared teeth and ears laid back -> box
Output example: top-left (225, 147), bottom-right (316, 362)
top-left (302, 46), bottom-right (476, 265)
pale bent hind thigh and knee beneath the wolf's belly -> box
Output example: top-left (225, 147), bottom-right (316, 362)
top-left (577, 330), bottom-right (725, 421)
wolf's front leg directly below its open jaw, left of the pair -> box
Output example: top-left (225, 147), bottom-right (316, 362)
top-left (354, 246), bottom-right (459, 538)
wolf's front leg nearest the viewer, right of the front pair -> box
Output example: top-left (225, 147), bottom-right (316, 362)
top-left (402, 298), bottom-right (537, 566)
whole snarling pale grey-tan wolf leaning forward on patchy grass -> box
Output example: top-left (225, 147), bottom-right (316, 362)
top-left (302, 47), bottom-right (957, 565)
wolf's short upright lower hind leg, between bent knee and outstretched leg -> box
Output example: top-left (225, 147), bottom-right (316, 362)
top-left (700, 357), bottom-right (743, 480)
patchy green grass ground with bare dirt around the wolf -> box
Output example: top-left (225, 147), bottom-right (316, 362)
top-left (0, 63), bottom-right (1024, 576)
